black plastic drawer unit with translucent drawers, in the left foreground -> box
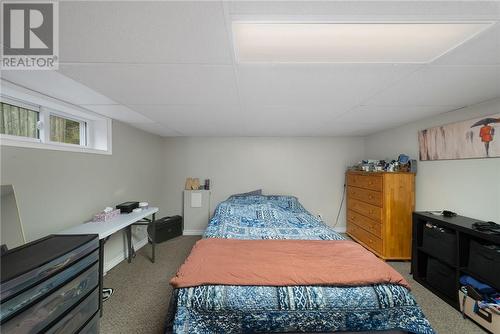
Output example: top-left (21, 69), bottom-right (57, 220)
top-left (0, 235), bottom-right (100, 334)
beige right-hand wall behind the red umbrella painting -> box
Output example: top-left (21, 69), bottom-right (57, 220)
top-left (365, 99), bottom-right (500, 223)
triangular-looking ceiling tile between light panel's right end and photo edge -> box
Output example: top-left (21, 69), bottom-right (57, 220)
top-left (432, 23), bottom-right (500, 65)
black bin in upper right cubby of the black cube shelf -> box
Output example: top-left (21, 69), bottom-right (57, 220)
top-left (467, 240), bottom-right (500, 289)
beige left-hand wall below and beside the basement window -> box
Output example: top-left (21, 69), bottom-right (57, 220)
top-left (0, 121), bottom-right (165, 270)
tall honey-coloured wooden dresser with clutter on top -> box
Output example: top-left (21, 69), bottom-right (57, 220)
top-left (346, 171), bottom-right (415, 260)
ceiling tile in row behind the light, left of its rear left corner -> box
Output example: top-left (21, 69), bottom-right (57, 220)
top-left (59, 64), bottom-right (238, 109)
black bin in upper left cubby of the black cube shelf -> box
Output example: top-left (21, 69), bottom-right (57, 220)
top-left (422, 226), bottom-right (457, 265)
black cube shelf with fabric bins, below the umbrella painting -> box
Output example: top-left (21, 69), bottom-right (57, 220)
top-left (411, 212), bottom-right (500, 309)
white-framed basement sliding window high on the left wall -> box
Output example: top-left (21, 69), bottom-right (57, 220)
top-left (0, 82), bottom-right (111, 154)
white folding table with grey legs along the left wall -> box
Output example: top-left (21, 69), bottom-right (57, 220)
top-left (56, 208), bottom-right (159, 316)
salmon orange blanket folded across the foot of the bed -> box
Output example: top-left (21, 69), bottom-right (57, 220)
top-left (170, 238), bottom-right (410, 289)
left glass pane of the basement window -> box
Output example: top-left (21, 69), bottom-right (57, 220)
top-left (0, 102), bottom-right (38, 139)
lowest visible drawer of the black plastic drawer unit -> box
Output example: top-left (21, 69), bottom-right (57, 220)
top-left (46, 288), bottom-right (99, 334)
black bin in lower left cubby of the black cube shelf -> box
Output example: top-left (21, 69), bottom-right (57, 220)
top-left (427, 257), bottom-right (458, 299)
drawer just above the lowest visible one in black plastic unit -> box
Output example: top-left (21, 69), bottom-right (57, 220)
top-left (2, 263), bottom-right (99, 333)
